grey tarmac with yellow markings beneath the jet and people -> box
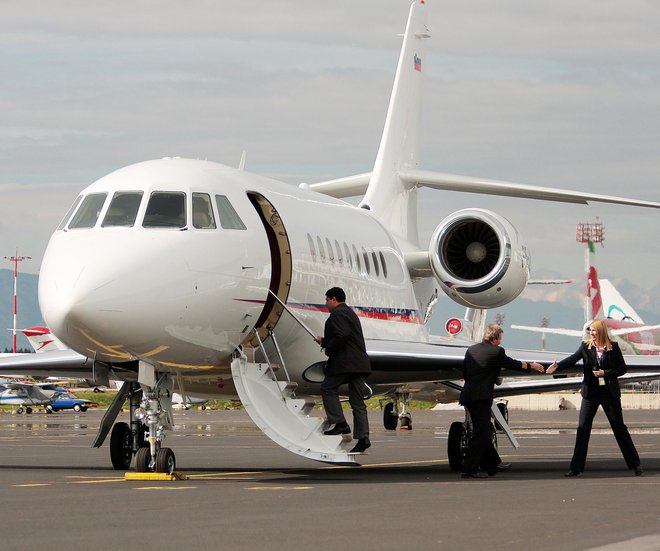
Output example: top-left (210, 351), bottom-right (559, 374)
top-left (0, 410), bottom-right (660, 551)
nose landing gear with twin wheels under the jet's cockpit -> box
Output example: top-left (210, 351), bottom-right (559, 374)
top-left (93, 374), bottom-right (176, 474)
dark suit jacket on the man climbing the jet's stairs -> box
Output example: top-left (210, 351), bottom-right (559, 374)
top-left (321, 303), bottom-right (371, 375)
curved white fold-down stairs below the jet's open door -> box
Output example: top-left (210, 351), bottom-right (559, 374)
top-left (231, 333), bottom-right (359, 465)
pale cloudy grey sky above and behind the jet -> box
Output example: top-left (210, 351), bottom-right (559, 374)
top-left (0, 0), bottom-right (660, 316)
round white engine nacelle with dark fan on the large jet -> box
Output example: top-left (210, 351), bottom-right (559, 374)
top-left (429, 209), bottom-right (529, 308)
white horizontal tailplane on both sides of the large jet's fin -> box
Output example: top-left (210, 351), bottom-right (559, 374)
top-left (301, 169), bottom-right (660, 209)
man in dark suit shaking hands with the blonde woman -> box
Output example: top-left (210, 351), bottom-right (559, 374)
top-left (459, 324), bottom-right (544, 478)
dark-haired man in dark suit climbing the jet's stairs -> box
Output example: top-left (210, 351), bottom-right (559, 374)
top-left (314, 287), bottom-right (371, 453)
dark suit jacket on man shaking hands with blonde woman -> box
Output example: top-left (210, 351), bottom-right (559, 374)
top-left (459, 340), bottom-right (531, 404)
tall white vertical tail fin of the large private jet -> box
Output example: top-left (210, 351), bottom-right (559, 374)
top-left (360, 0), bottom-right (430, 244)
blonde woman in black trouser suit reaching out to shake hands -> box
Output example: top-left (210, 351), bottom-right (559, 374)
top-left (546, 320), bottom-right (643, 477)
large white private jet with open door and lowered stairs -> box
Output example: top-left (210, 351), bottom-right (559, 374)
top-left (0, 0), bottom-right (660, 472)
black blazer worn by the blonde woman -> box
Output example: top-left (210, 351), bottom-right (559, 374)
top-left (557, 342), bottom-right (628, 398)
